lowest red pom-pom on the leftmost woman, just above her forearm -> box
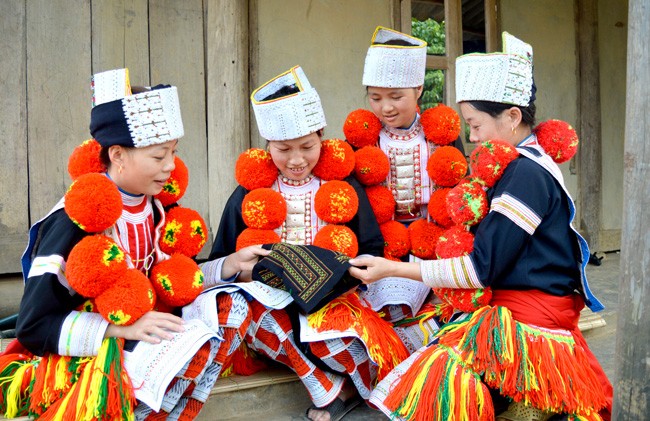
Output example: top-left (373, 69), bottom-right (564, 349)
top-left (95, 269), bottom-right (156, 326)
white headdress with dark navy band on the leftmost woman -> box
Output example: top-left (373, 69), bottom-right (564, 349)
top-left (90, 69), bottom-right (185, 148)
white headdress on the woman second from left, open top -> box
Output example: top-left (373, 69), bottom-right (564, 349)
top-left (251, 66), bottom-right (327, 140)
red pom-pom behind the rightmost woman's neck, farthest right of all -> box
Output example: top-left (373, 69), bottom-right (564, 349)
top-left (534, 120), bottom-right (579, 164)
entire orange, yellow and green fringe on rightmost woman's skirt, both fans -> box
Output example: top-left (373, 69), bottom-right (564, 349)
top-left (384, 306), bottom-right (605, 421)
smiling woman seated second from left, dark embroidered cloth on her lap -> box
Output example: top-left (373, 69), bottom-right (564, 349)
top-left (202, 67), bottom-right (408, 420)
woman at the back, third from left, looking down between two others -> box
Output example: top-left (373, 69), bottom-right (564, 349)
top-left (344, 27), bottom-right (466, 360)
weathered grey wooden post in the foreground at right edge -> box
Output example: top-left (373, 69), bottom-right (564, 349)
top-left (612, 0), bottom-right (650, 421)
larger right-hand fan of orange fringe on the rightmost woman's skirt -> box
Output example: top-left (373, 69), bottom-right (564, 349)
top-left (440, 306), bottom-right (605, 419)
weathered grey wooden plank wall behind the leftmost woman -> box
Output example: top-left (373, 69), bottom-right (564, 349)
top-left (0, 0), bottom-right (242, 275)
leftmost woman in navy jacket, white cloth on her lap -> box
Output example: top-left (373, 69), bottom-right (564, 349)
top-left (6, 69), bottom-right (219, 419)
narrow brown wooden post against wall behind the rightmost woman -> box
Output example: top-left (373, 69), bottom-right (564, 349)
top-left (577, 0), bottom-right (602, 252)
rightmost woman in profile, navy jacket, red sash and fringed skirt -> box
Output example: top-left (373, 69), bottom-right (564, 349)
top-left (350, 32), bottom-right (612, 421)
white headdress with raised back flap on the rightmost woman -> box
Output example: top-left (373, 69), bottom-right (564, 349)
top-left (456, 32), bottom-right (534, 107)
